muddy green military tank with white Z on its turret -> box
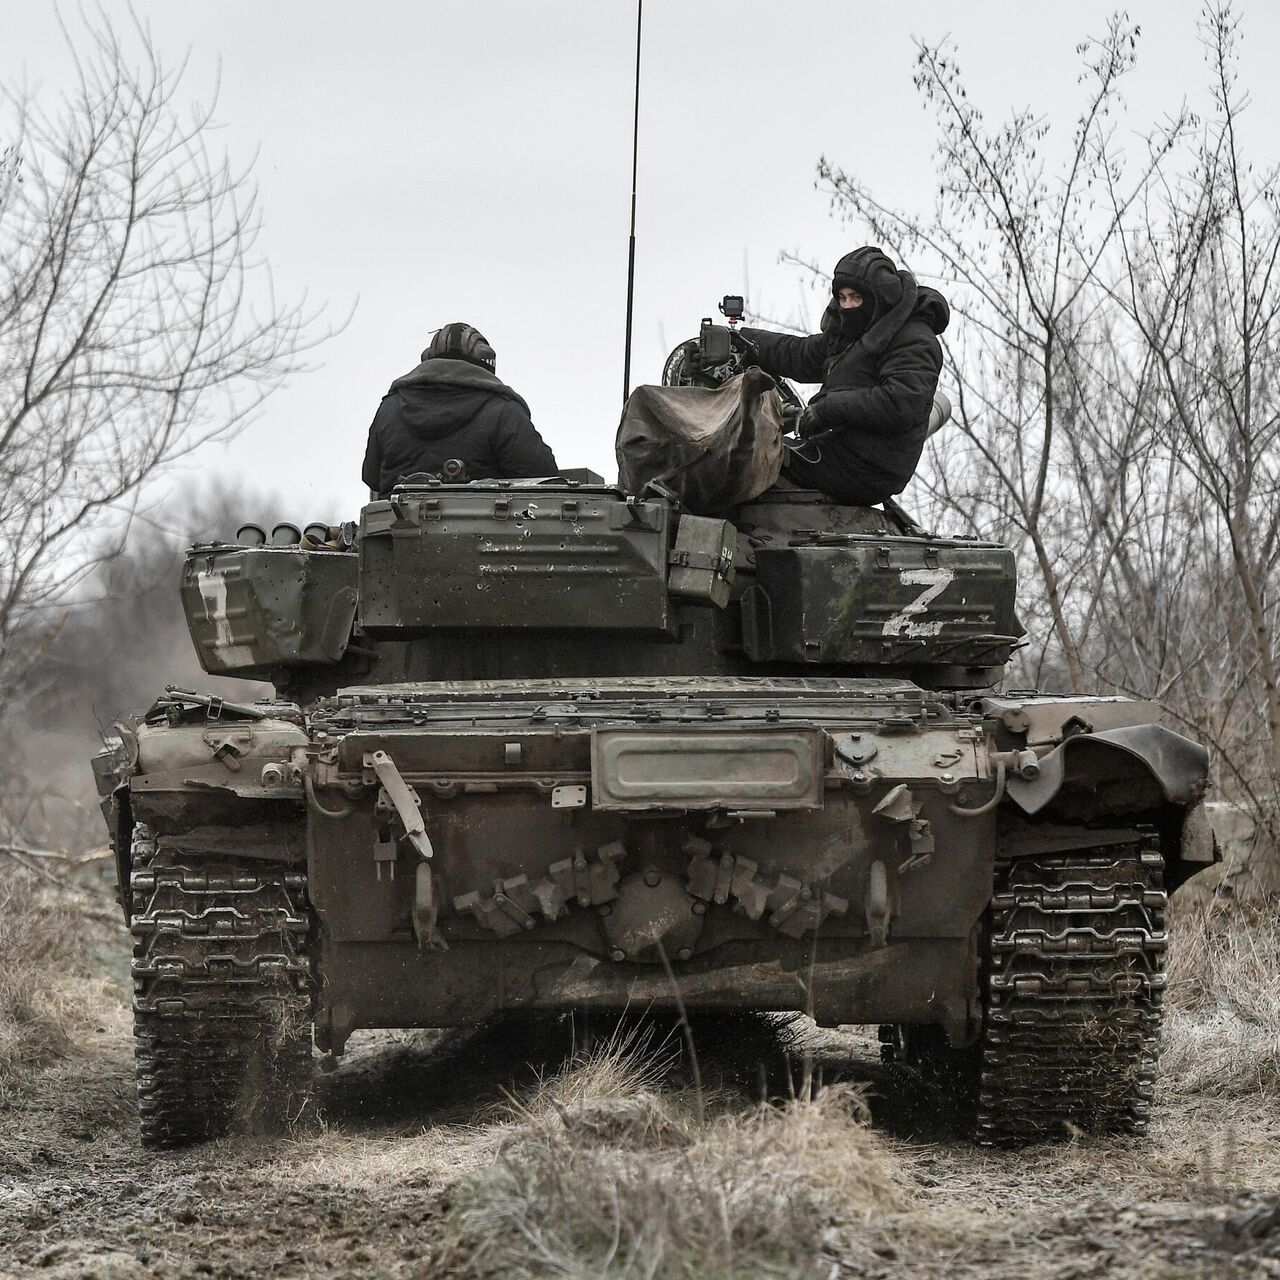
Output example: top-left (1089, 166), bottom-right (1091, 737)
top-left (95, 317), bottom-right (1215, 1147)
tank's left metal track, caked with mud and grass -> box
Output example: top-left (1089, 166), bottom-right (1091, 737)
top-left (131, 837), bottom-right (312, 1147)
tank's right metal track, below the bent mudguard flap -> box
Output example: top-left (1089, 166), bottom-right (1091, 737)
top-left (881, 838), bottom-right (1167, 1146)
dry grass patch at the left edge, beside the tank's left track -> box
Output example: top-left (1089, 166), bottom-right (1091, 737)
top-left (0, 864), bottom-right (119, 1107)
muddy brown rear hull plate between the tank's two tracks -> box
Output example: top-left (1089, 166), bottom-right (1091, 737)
top-left (296, 678), bottom-right (996, 1043)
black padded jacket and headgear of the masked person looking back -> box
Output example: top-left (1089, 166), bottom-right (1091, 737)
top-left (740, 247), bottom-right (951, 506)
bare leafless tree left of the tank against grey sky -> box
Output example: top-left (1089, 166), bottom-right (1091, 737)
top-left (0, 10), bottom-right (325, 710)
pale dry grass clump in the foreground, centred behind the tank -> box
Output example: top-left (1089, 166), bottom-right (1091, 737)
top-left (433, 1024), bottom-right (908, 1280)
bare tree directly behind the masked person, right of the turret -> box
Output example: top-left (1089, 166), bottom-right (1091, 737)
top-left (819, 18), bottom-right (1189, 690)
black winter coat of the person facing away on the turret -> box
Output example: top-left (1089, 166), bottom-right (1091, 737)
top-left (361, 366), bottom-right (557, 495)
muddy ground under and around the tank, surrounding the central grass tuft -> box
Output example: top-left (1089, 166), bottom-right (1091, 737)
top-left (0, 911), bottom-right (1280, 1280)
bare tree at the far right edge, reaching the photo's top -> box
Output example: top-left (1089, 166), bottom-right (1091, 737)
top-left (1111, 4), bottom-right (1280, 891)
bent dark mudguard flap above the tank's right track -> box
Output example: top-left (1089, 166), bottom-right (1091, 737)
top-left (1006, 724), bottom-right (1208, 814)
